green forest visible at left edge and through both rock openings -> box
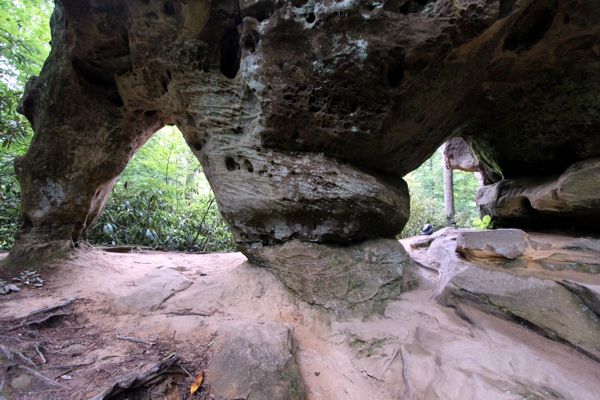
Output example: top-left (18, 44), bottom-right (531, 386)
top-left (0, 0), bottom-right (479, 252)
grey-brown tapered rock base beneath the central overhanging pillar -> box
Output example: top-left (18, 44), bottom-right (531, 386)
top-left (245, 239), bottom-right (418, 317)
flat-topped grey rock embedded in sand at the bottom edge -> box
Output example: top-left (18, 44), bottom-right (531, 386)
top-left (206, 320), bottom-right (306, 400)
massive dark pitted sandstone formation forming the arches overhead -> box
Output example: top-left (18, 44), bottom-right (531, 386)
top-left (11, 0), bottom-right (600, 300)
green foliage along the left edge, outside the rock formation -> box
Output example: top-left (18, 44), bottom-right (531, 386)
top-left (0, 0), bottom-right (54, 250)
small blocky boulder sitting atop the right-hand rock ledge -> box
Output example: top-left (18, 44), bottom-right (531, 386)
top-left (456, 229), bottom-right (528, 260)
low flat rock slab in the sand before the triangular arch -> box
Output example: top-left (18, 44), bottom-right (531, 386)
top-left (115, 268), bottom-right (193, 312)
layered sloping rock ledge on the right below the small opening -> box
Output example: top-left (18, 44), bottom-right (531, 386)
top-left (411, 229), bottom-right (600, 360)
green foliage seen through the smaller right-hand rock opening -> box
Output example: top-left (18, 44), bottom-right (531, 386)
top-left (399, 148), bottom-right (479, 238)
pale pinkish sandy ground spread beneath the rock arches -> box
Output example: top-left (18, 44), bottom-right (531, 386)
top-left (0, 241), bottom-right (600, 399)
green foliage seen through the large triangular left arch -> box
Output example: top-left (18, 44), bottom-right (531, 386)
top-left (89, 128), bottom-right (235, 251)
